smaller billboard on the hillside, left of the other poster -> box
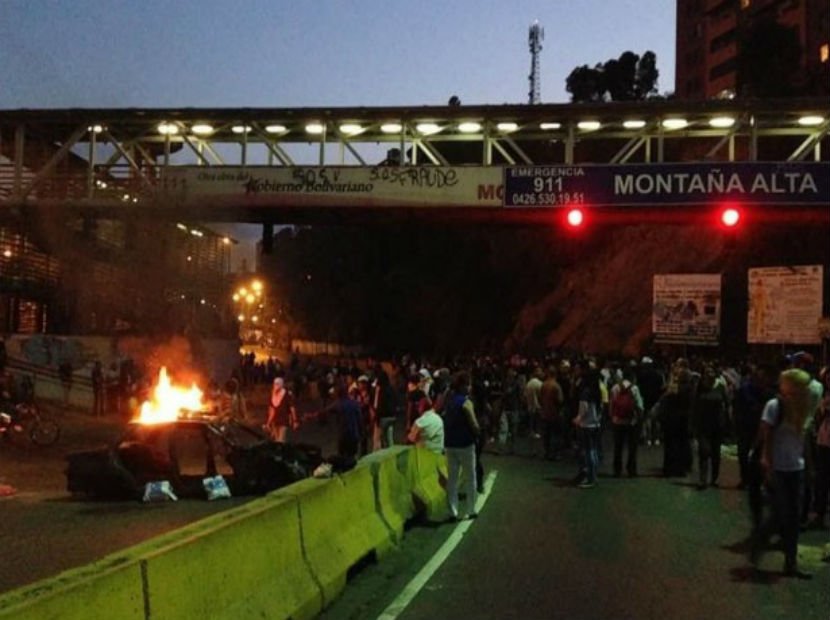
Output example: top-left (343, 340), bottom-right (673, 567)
top-left (651, 273), bottom-right (721, 346)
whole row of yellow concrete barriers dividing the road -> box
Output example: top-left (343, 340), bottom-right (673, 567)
top-left (0, 447), bottom-right (422, 620)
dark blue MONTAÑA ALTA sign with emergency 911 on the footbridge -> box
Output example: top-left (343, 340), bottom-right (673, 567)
top-left (504, 162), bottom-right (830, 207)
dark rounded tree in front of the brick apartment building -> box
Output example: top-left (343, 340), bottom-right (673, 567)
top-left (737, 17), bottom-right (802, 97)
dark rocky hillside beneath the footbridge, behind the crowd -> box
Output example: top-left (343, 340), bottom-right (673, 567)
top-left (266, 220), bottom-right (830, 354)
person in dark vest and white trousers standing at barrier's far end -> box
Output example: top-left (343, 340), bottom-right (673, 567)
top-left (444, 371), bottom-right (481, 520)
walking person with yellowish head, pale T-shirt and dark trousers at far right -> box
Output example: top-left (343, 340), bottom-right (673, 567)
top-left (750, 368), bottom-right (812, 578)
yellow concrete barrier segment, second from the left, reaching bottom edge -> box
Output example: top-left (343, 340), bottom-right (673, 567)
top-left (142, 496), bottom-right (323, 620)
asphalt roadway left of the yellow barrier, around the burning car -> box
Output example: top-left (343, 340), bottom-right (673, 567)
top-left (0, 387), bottom-right (344, 593)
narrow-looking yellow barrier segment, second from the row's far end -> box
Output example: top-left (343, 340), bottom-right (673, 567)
top-left (360, 446), bottom-right (415, 543)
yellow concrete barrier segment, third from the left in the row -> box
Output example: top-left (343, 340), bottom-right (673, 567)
top-left (272, 464), bottom-right (392, 605)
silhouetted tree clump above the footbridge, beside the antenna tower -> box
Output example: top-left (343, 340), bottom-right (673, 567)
top-left (565, 51), bottom-right (659, 103)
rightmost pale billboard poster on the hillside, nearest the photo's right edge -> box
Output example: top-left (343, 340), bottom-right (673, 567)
top-left (746, 265), bottom-right (824, 344)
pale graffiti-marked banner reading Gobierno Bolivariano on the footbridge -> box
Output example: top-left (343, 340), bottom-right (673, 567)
top-left (162, 166), bottom-right (503, 207)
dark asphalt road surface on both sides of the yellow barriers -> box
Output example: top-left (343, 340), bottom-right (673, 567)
top-left (0, 402), bottom-right (830, 620)
